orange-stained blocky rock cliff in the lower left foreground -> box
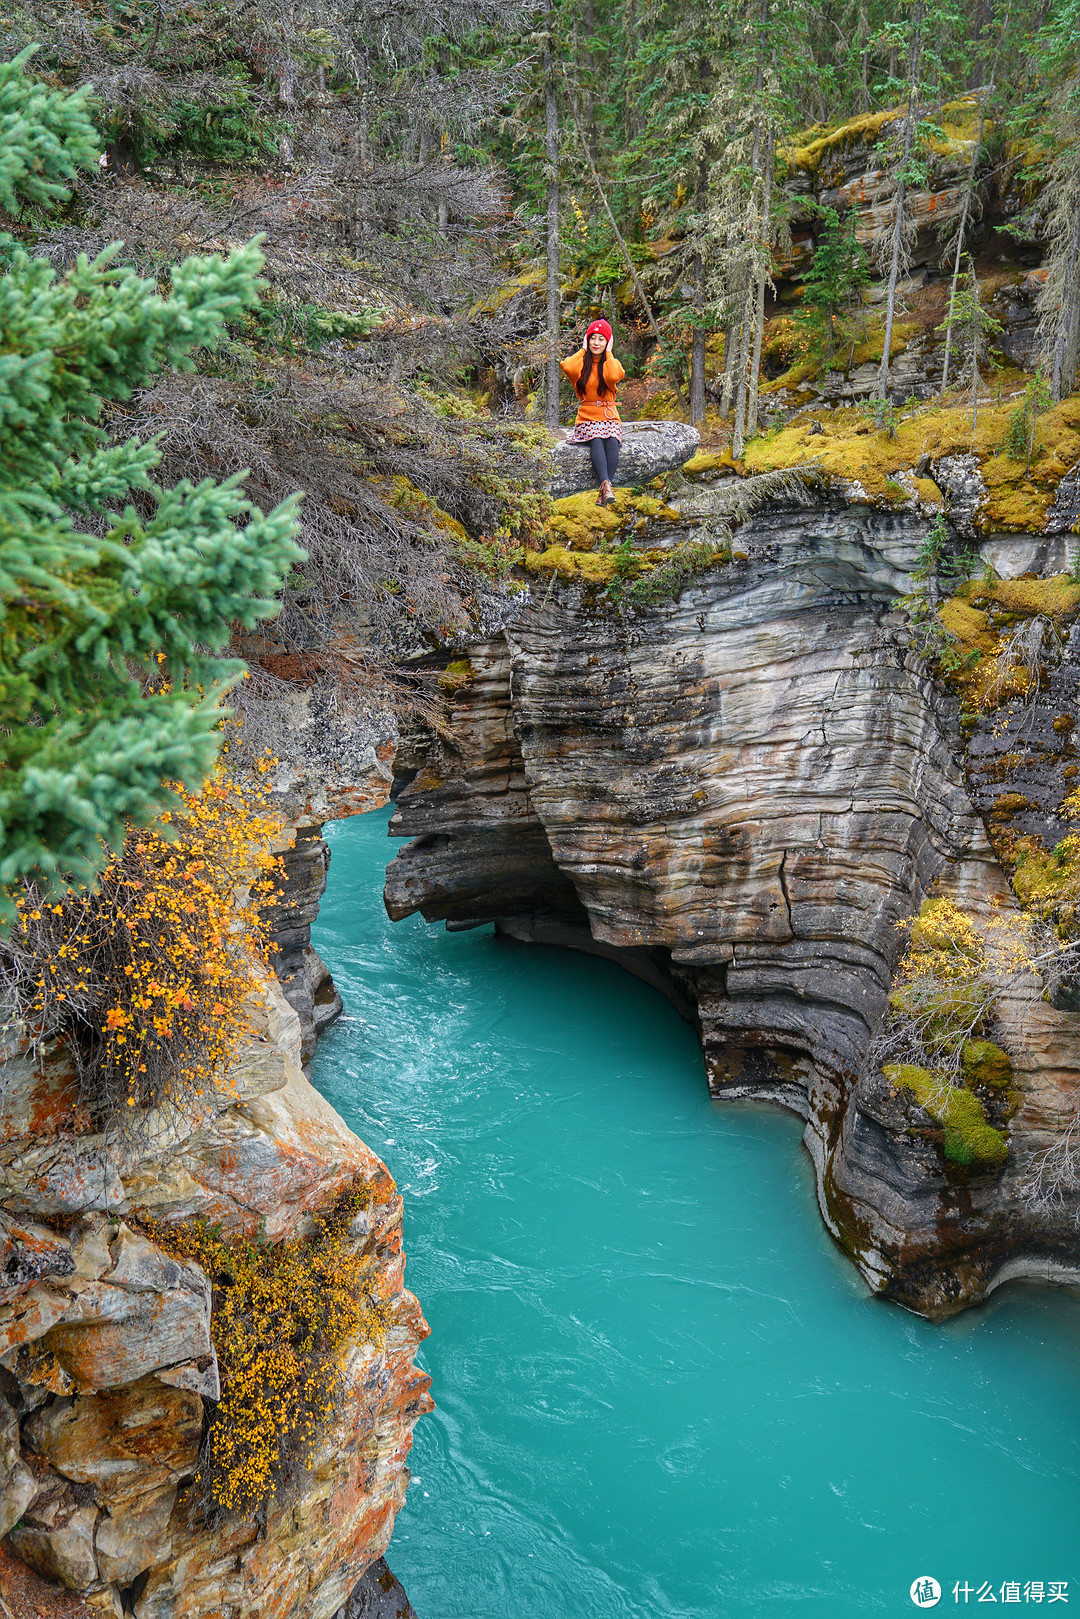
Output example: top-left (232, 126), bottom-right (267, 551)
top-left (0, 971), bottom-right (431, 1619)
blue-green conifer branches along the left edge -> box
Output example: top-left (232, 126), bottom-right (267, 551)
top-left (0, 50), bottom-right (303, 905)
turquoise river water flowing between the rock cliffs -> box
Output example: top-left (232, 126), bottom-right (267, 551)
top-left (314, 814), bottom-right (1080, 1619)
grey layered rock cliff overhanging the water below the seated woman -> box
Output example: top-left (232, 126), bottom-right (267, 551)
top-left (385, 488), bottom-right (1080, 1315)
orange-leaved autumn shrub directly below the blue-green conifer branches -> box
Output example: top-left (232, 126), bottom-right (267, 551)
top-left (3, 761), bottom-right (280, 1125)
